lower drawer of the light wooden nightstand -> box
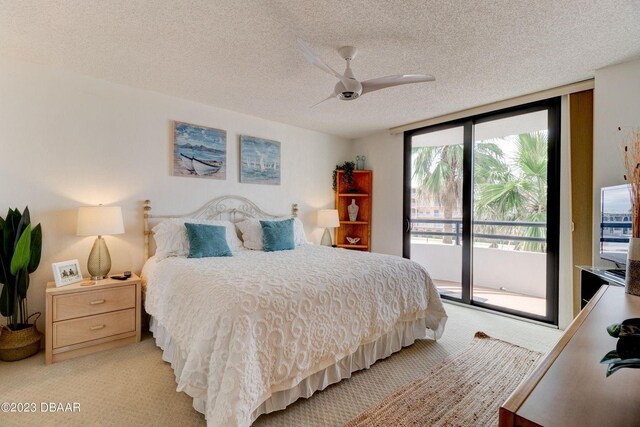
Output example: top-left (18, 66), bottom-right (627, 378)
top-left (53, 308), bottom-right (136, 348)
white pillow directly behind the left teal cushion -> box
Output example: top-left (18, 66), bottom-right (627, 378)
top-left (153, 218), bottom-right (242, 260)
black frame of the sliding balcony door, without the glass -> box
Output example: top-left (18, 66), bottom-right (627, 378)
top-left (402, 97), bottom-right (561, 325)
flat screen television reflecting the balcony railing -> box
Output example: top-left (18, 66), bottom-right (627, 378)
top-left (600, 184), bottom-right (631, 266)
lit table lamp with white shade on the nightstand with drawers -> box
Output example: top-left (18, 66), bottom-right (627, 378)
top-left (76, 205), bottom-right (124, 280)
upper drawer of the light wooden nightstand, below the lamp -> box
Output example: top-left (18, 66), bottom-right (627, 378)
top-left (53, 285), bottom-right (136, 322)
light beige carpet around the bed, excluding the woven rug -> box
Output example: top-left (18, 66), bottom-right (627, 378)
top-left (0, 304), bottom-right (561, 427)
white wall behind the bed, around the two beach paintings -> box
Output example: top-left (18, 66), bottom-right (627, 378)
top-left (0, 59), bottom-right (352, 332)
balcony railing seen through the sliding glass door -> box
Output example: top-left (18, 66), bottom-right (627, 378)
top-left (409, 218), bottom-right (547, 245)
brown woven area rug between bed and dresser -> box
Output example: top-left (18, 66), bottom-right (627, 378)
top-left (344, 332), bottom-right (542, 427)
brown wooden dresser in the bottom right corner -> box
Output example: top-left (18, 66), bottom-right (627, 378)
top-left (500, 286), bottom-right (640, 427)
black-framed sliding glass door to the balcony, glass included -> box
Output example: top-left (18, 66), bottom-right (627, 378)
top-left (404, 99), bottom-right (560, 324)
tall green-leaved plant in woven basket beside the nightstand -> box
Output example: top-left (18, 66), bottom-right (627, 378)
top-left (0, 207), bottom-right (42, 361)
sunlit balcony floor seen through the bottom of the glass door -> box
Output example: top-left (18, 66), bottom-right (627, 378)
top-left (433, 279), bottom-right (547, 316)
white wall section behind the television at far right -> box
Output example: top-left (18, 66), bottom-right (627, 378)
top-left (593, 60), bottom-right (640, 266)
